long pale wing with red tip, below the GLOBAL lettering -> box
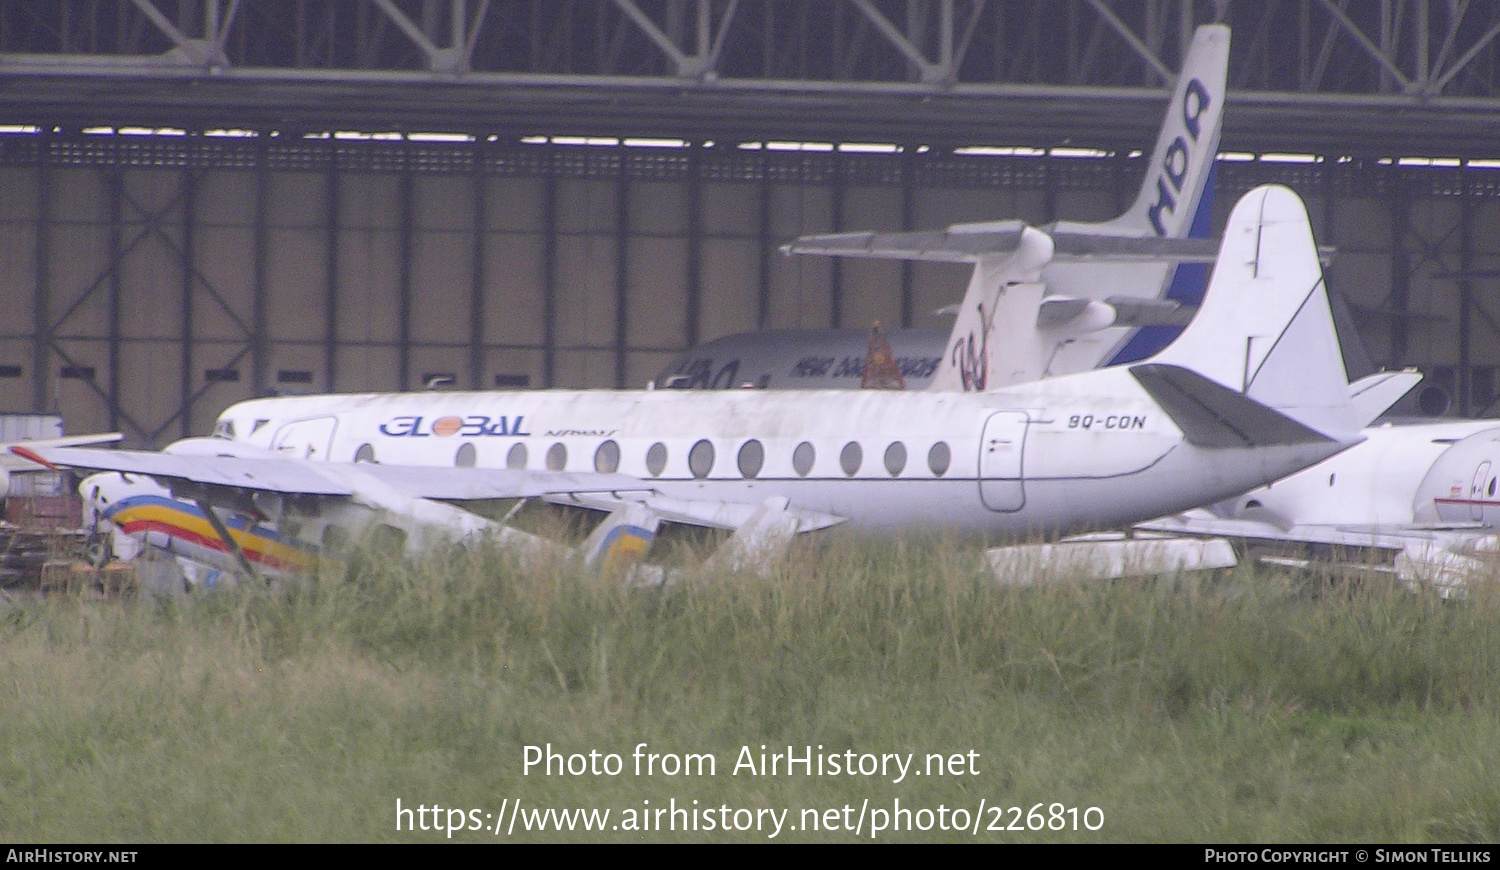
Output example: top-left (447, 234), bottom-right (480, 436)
top-left (11, 446), bottom-right (651, 501)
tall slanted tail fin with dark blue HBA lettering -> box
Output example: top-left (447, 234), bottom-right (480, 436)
top-left (1097, 24), bottom-right (1230, 239)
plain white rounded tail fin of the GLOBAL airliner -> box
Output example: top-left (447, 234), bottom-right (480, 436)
top-left (1131, 186), bottom-right (1367, 440)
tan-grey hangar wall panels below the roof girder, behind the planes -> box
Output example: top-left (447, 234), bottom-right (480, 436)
top-left (0, 134), bottom-right (1500, 447)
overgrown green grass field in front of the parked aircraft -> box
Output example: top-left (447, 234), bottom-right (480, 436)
top-left (0, 540), bottom-right (1500, 843)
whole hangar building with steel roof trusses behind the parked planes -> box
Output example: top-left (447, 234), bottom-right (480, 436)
top-left (0, 0), bottom-right (1500, 447)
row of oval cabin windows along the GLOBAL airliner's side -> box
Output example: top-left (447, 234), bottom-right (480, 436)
top-left (354, 438), bottom-right (953, 479)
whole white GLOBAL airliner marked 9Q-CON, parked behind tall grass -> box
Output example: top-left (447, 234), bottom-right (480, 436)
top-left (23, 186), bottom-right (1368, 588)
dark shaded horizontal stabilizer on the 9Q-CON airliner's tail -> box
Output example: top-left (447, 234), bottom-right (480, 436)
top-left (1130, 363), bottom-right (1334, 447)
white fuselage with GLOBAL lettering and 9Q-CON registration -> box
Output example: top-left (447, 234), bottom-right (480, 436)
top-left (218, 369), bottom-right (1338, 534)
